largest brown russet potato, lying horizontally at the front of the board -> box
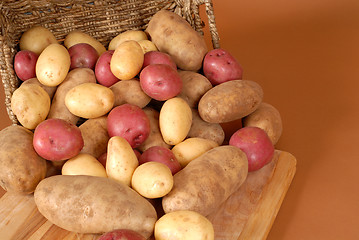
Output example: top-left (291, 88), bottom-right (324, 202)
top-left (34, 175), bottom-right (157, 239)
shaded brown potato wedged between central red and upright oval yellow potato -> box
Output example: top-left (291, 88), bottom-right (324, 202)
top-left (137, 107), bottom-right (170, 152)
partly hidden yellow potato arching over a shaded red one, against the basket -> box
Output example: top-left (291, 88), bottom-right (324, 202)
top-left (64, 30), bottom-right (106, 56)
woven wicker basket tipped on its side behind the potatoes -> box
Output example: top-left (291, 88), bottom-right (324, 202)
top-left (0, 0), bottom-right (219, 124)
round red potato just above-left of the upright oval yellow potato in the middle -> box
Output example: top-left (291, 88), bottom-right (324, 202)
top-left (140, 64), bottom-right (182, 101)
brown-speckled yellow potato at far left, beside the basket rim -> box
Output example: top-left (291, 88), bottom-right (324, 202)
top-left (11, 84), bottom-right (51, 129)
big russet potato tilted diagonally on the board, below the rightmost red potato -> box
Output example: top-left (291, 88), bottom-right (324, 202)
top-left (162, 145), bottom-right (248, 216)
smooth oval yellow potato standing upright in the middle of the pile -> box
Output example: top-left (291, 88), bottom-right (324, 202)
top-left (159, 97), bottom-right (192, 145)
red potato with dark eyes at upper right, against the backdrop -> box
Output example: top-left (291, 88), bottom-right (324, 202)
top-left (203, 48), bottom-right (243, 85)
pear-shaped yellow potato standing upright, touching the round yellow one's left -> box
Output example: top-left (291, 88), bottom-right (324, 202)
top-left (106, 136), bottom-right (138, 186)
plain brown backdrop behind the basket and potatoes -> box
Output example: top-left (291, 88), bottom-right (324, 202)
top-left (0, 0), bottom-right (359, 240)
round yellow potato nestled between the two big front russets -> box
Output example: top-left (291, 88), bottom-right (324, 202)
top-left (131, 162), bottom-right (173, 199)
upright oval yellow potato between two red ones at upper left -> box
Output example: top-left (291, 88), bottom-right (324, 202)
top-left (35, 43), bottom-right (71, 87)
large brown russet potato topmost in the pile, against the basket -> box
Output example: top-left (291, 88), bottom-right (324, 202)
top-left (146, 10), bottom-right (208, 71)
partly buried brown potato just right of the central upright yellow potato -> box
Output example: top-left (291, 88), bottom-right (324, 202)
top-left (188, 108), bottom-right (225, 145)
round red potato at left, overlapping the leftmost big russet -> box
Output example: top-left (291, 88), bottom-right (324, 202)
top-left (33, 118), bottom-right (84, 161)
